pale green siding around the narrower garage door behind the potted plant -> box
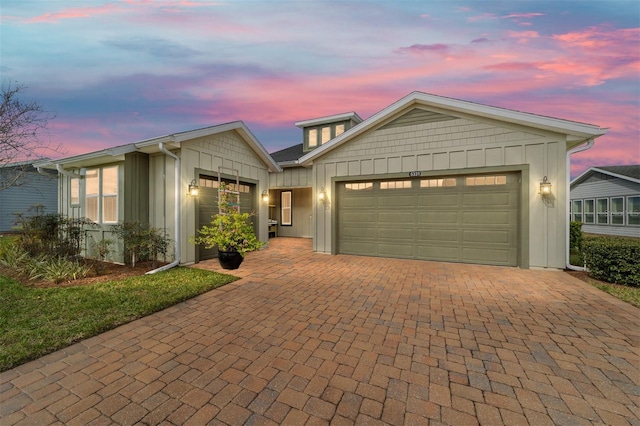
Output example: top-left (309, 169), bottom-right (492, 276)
top-left (149, 131), bottom-right (268, 263)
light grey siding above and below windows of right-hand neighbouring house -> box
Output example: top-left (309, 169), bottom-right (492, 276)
top-left (571, 178), bottom-right (640, 238)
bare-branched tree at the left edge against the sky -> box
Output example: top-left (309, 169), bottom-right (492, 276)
top-left (0, 83), bottom-right (63, 191)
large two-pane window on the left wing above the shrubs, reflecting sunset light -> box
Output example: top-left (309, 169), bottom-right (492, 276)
top-left (85, 166), bottom-right (118, 223)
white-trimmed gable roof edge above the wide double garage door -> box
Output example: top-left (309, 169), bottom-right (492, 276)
top-left (296, 92), bottom-right (607, 165)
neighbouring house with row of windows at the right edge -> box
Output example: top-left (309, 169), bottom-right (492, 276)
top-left (571, 165), bottom-right (640, 237)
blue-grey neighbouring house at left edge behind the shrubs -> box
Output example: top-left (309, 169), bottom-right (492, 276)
top-left (0, 161), bottom-right (58, 234)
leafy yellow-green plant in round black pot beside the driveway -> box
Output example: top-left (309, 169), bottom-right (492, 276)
top-left (191, 183), bottom-right (262, 269)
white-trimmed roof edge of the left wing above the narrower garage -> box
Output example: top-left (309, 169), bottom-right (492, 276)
top-left (34, 121), bottom-right (282, 172)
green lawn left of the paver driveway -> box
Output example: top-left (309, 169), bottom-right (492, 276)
top-left (0, 268), bottom-right (237, 371)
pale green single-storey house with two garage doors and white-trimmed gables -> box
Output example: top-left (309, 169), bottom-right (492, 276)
top-left (33, 92), bottom-right (606, 268)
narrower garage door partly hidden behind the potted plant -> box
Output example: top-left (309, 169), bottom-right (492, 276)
top-left (196, 176), bottom-right (255, 261)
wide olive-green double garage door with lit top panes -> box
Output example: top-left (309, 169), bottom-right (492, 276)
top-left (337, 173), bottom-right (520, 266)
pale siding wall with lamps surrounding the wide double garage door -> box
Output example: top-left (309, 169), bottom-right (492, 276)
top-left (313, 112), bottom-right (566, 268)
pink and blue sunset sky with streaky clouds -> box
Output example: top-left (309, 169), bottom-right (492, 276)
top-left (0, 0), bottom-right (640, 177)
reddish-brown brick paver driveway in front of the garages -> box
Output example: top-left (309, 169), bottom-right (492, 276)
top-left (0, 238), bottom-right (640, 425)
